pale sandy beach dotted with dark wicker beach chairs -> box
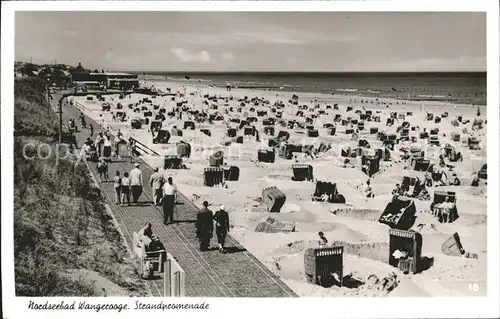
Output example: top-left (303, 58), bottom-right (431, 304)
top-left (74, 80), bottom-right (487, 297)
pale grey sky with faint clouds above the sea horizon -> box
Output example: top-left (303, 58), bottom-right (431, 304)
top-left (15, 11), bottom-right (486, 72)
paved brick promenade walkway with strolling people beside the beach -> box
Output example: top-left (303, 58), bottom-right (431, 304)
top-left (52, 94), bottom-right (296, 297)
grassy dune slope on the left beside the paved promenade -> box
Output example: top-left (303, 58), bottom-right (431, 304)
top-left (13, 79), bottom-right (145, 296)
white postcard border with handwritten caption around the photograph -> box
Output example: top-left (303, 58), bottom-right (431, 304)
top-left (1, 0), bottom-right (500, 319)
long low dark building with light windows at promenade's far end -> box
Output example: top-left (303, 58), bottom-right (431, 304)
top-left (71, 71), bottom-right (139, 90)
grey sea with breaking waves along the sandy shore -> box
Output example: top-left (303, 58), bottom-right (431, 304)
top-left (129, 72), bottom-right (486, 105)
